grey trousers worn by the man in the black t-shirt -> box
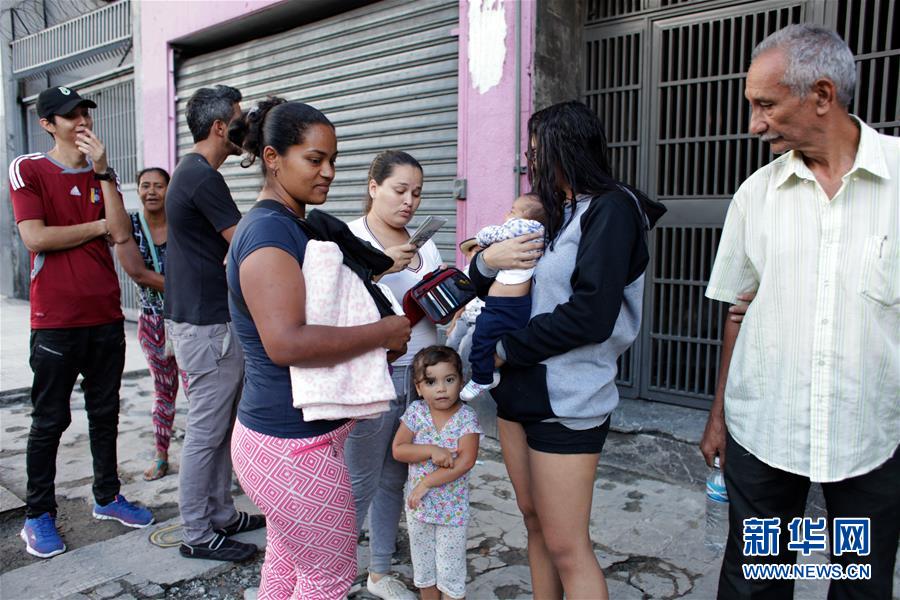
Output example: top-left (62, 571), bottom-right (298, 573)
top-left (166, 321), bottom-right (244, 544)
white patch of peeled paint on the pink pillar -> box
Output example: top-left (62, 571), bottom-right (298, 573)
top-left (468, 0), bottom-right (515, 94)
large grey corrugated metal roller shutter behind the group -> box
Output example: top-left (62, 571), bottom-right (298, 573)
top-left (176, 0), bottom-right (459, 260)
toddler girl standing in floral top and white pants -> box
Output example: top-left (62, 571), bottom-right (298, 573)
top-left (393, 346), bottom-right (481, 600)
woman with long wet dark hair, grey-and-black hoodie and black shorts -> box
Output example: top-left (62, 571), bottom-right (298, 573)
top-left (469, 102), bottom-right (653, 599)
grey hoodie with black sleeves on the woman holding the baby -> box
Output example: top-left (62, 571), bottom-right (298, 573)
top-left (470, 191), bottom-right (649, 430)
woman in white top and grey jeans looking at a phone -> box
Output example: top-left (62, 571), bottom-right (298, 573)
top-left (345, 150), bottom-right (441, 600)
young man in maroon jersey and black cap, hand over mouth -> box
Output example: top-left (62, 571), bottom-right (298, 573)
top-left (9, 87), bottom-right (153, 558)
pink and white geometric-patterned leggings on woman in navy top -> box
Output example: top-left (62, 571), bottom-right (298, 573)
top-left (231, 420), bottom-right (357, 600)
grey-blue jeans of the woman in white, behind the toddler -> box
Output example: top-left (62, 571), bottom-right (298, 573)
top-left (344, 367), bottom-right (415, 573)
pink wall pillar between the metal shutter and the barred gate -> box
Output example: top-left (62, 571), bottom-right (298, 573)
top-left (456, 0), bottom-right (535, 264)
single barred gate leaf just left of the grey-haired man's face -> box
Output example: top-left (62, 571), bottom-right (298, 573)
top-left (641, 2), bottom-right (803, 405)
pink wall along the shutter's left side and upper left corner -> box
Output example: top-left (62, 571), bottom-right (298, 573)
top-left (135, 0), bottom-right (281, 171)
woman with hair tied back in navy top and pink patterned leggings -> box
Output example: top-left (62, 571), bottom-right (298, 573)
top-left (225, 98), bottom-right (410, 600)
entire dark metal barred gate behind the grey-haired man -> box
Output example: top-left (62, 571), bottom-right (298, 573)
top-left (583, 0), bottom-right (900, 408)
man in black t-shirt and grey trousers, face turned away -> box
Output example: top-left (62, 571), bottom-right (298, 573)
top-left (165, 85), bottom-right (265, 561)
